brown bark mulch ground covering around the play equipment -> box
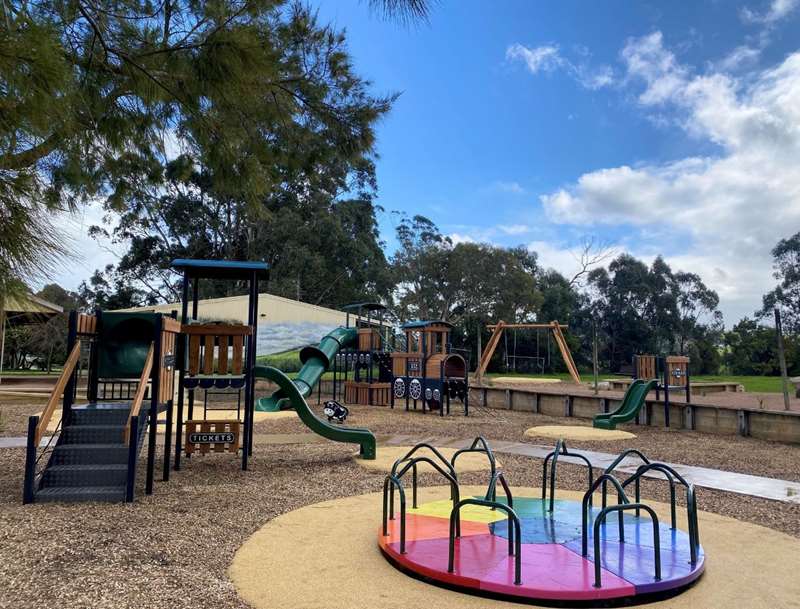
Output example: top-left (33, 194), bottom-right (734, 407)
top-left (0, 400), bottom-right (800, 609)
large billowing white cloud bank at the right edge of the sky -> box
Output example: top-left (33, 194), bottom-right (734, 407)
top-left (540, 32), bottom-right (800, 323)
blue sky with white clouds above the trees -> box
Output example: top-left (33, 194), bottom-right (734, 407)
top-left (57, 0), bottom-right (800, 326)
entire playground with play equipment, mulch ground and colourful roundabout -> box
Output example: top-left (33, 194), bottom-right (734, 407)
top-left (0, 259), bottom-right (800, 609)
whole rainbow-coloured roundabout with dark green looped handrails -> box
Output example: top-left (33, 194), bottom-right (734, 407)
top-left (378, 438), bottom-right (705, 604)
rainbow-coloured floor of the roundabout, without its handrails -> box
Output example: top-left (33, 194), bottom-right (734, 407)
top-left (378, 498), bottom-right (705, 602)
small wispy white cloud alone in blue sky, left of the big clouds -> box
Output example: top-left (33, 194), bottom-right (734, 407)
top-left (506, 43), bottom-right (615, 90)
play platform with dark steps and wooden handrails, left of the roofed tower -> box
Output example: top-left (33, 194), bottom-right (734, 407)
top-left (23, 310), bottom-right (181, 503)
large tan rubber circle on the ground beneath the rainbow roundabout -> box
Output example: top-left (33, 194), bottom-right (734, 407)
top-left (228, 487), bottom-right (800, 609)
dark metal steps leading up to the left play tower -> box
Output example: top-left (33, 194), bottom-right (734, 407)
top-left (33, 403), bottom-right (148, 503)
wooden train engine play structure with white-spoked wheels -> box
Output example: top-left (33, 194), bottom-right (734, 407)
top-left (391, 320), bottom-right (469, 416)
